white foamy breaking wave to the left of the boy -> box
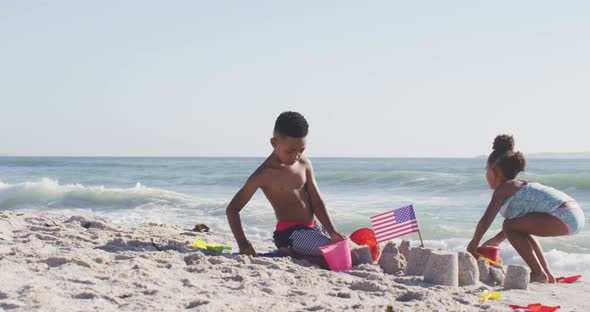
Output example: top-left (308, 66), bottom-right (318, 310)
top-left (0, 178), bottom-right (274, 239)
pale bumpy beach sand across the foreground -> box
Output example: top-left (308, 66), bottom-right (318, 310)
top-left (0, 211), bottom-right (590, 312)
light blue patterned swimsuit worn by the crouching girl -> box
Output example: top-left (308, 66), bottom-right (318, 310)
top-left (500, 182), bottom-right (585, 234)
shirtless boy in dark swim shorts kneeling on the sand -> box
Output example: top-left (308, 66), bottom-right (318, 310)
top-left (226, 112), bottom-right (346, 256)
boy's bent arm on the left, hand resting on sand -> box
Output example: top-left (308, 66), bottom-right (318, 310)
top-left (225, 172), bottom-right (258, 256)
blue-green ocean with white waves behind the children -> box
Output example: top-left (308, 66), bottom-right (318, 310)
top-left (0, 157), bottom-right (590, 274)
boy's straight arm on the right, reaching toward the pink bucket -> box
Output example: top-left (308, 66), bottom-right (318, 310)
top-left (305, 159), bottom-right (346, 241)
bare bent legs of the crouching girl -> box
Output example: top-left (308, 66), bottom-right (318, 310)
top-left (502, 212), bottom-right (569, 283)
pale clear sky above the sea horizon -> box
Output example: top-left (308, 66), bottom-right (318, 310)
top-left (0, 0), bottom-right (590, 157)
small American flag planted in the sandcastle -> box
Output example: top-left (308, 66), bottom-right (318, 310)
top-left (371, 205), bottom-right (418, 243)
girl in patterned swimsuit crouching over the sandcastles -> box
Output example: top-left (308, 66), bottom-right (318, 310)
top-left (467, 135), bottom-right (584, 283)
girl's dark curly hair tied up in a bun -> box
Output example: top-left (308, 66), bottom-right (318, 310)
top-left (488, 134), bottom-right (526, 179)
